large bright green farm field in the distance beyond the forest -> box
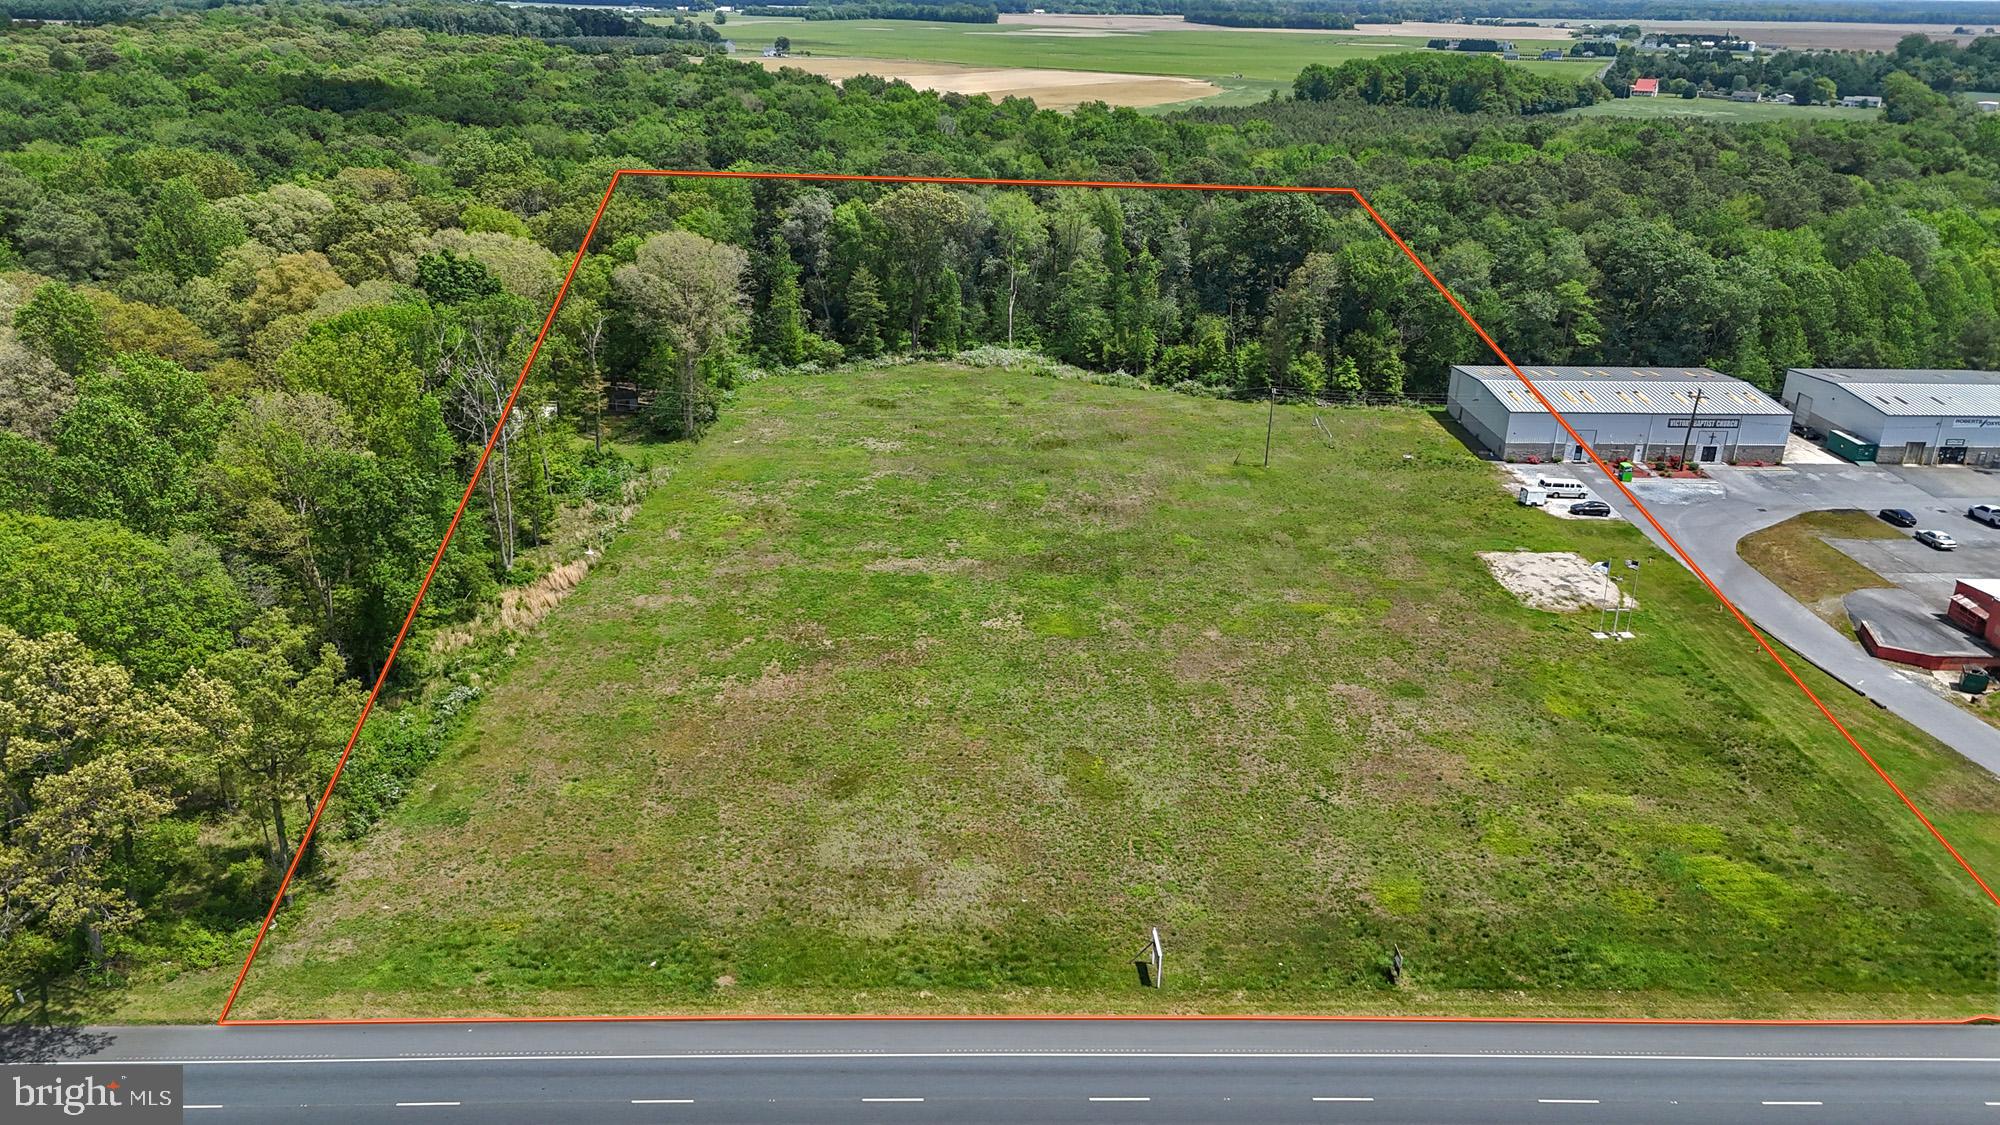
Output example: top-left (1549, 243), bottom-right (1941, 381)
top-left (724, 16), bottom-right (1602, 104)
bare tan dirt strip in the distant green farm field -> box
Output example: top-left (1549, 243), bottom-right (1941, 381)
top-left (758, 56), bottom-right (1222, 110)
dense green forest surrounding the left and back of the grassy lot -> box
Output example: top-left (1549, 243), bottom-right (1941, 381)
top-left (0, 2), bottom-right (2000, 996)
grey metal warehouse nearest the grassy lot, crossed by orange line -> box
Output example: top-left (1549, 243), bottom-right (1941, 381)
top-left (1446, 366), bottom-right (1792, 464)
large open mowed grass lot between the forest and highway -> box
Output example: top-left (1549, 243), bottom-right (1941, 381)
top-left (120, 366), bottom-right (2000, 1019)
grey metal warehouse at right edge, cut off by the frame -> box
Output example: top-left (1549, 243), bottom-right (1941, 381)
top-left (1784, 366), bottom-right (2000, 464)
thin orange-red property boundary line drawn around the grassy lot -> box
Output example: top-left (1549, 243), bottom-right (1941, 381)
top-left (216, 168), bottom-right (2000, 1027)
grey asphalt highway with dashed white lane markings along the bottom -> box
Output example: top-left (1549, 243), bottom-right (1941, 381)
top-left (0, 1021), bottom-right (2000, 1125)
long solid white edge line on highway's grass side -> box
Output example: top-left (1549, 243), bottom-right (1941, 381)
top-left (74, 1051), bottom-right (2000, 1067)
